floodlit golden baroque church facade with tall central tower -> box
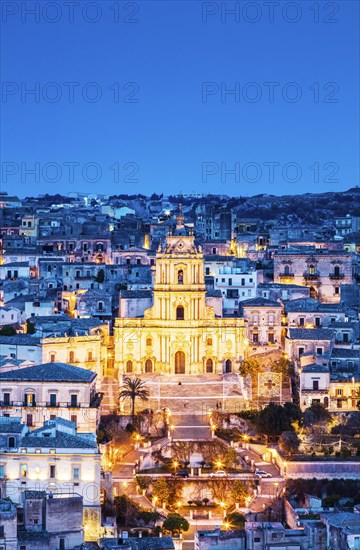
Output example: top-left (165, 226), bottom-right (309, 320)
top-left (114, 214), bottom-right (246, 380)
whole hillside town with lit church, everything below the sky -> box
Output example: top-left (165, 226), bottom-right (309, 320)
top-left (0, 188), bottom-right (360, 550)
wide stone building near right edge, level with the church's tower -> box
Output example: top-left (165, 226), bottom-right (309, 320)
top-left (274, 247), bottom-right (353, 303)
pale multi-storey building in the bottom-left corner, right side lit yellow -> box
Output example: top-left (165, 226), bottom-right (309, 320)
top-left (0, 417), bottom-right (100, 540)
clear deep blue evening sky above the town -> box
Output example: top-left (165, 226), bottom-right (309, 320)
top-left (1, 0), bottom-right (359, 196)
